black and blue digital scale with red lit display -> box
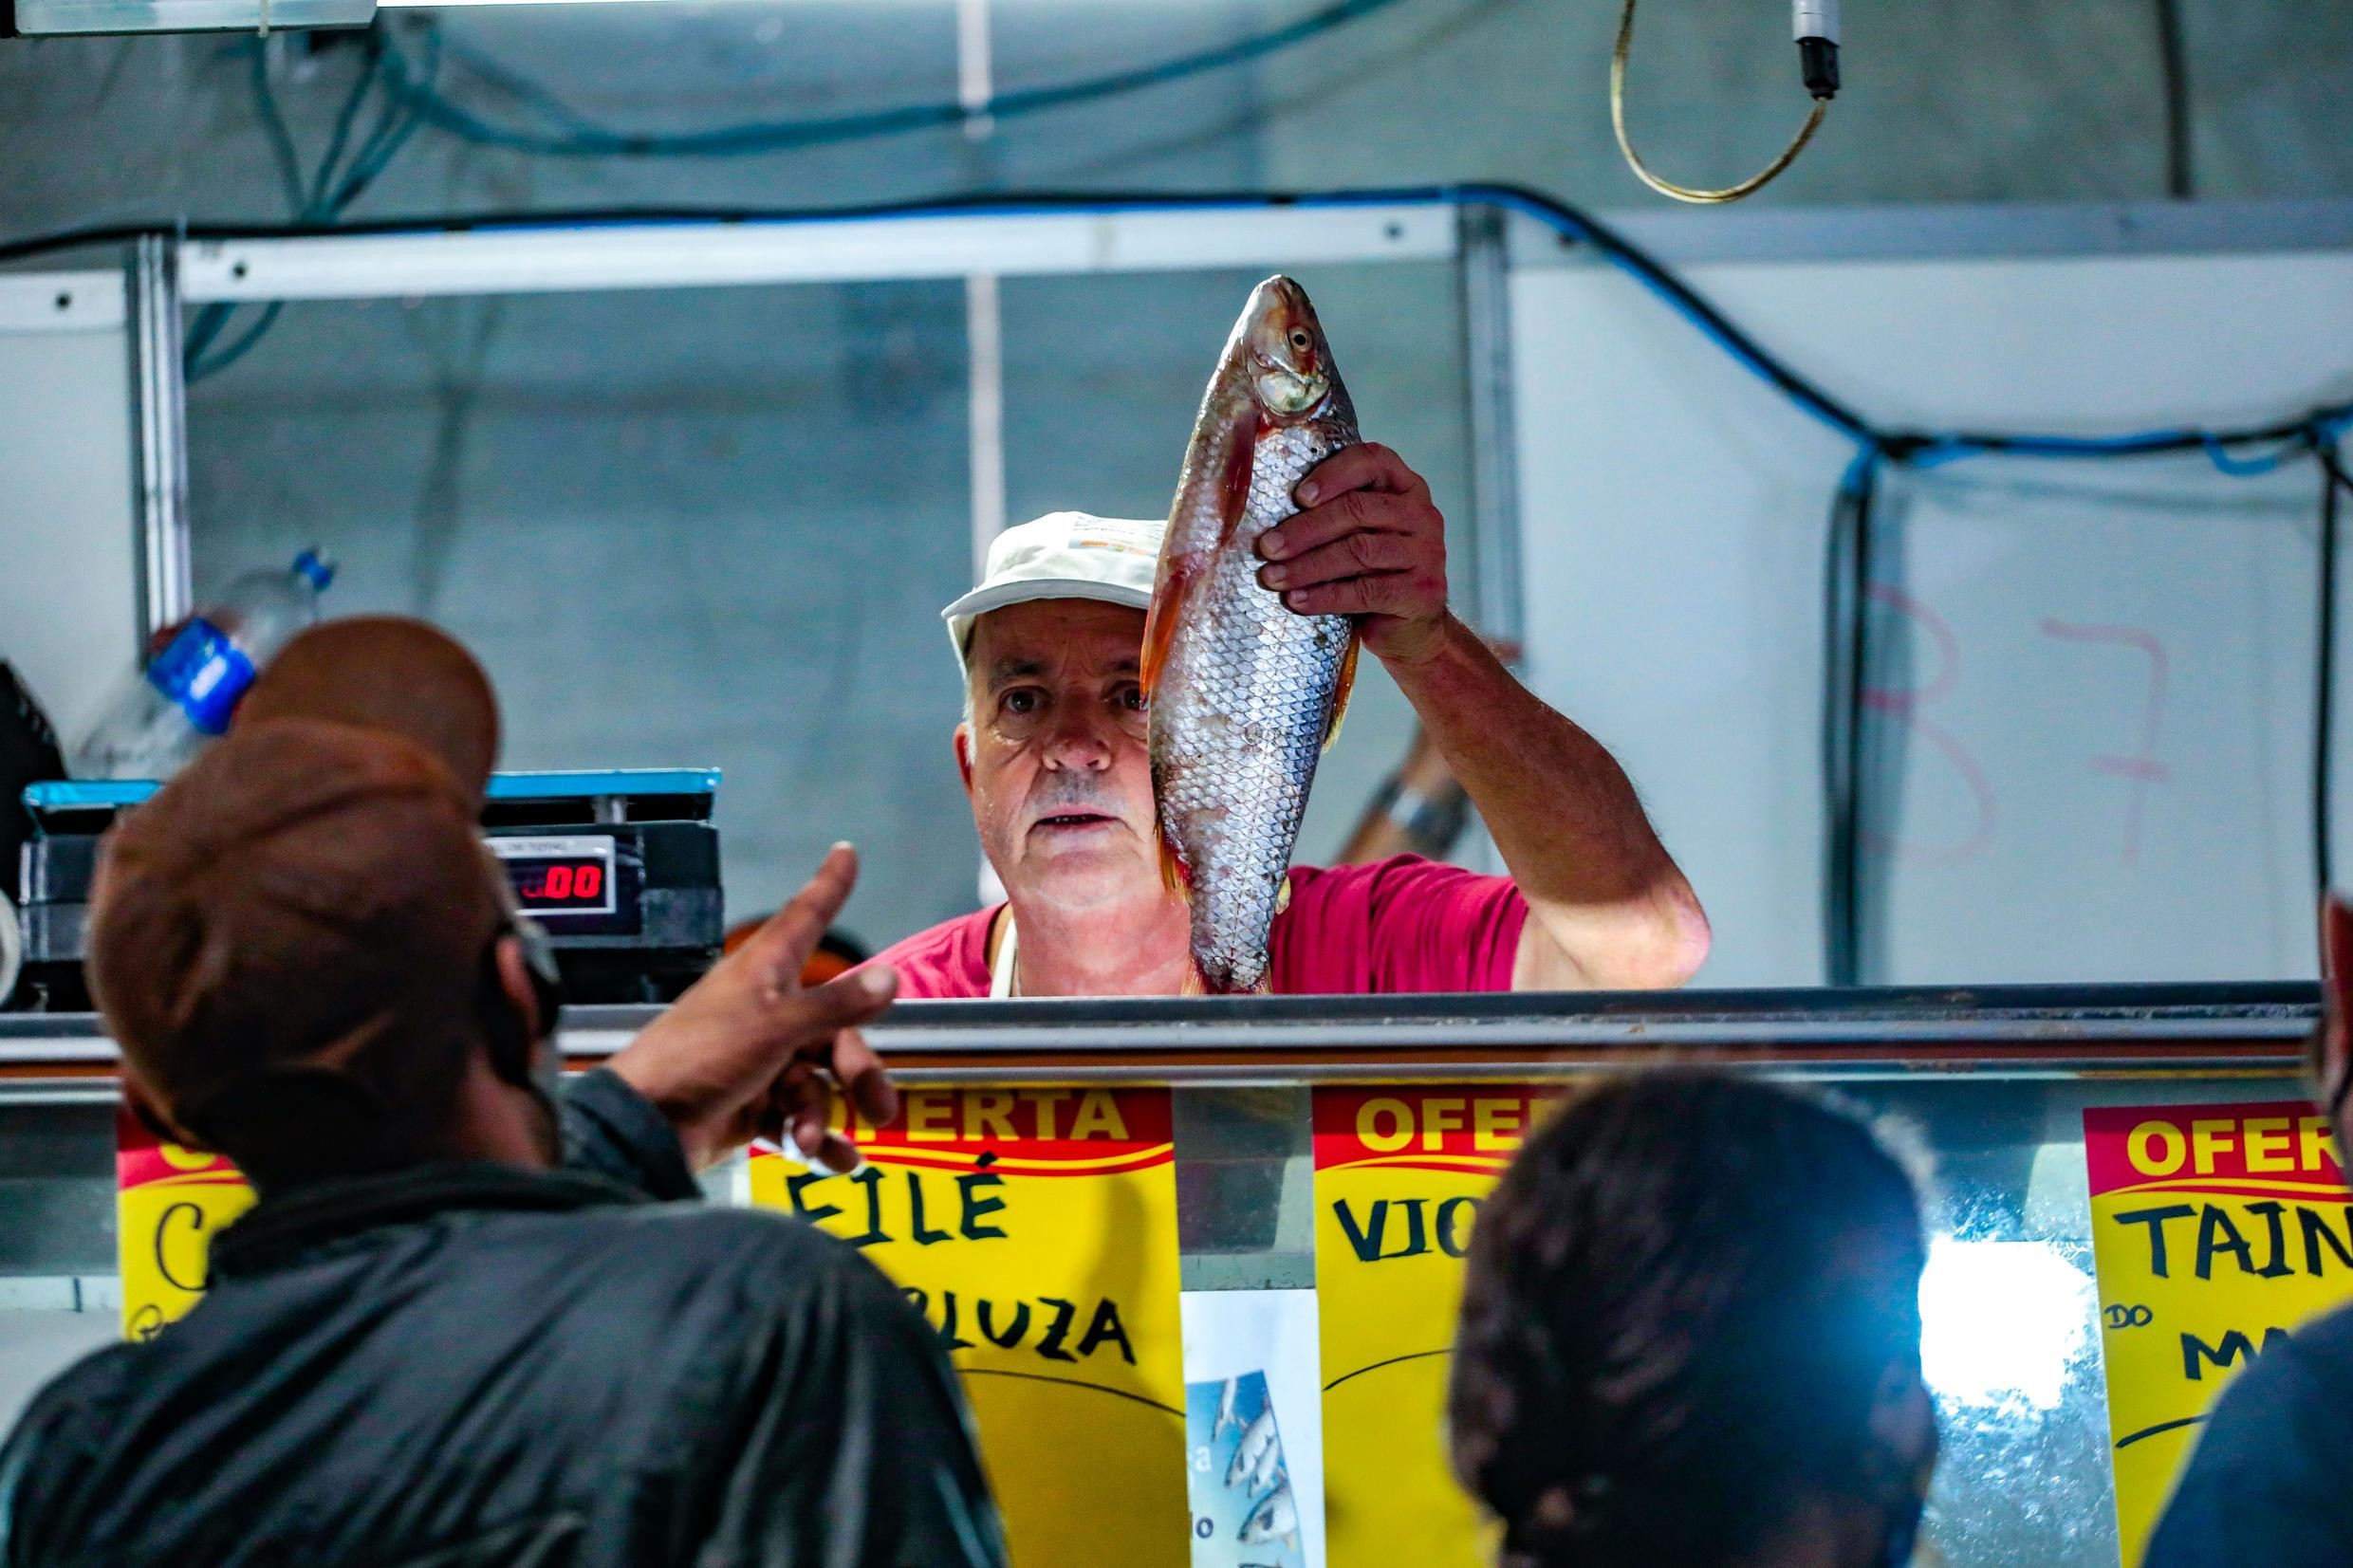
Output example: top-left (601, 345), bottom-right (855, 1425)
top-left (14, 768), bottom-right (725, 1013)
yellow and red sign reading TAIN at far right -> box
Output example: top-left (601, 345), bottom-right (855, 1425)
top-left (2083, 1100), bottom-right (2353, 1568)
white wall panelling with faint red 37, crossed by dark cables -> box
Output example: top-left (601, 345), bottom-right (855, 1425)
top-left (1513, 251), bottom-right (2353, 985)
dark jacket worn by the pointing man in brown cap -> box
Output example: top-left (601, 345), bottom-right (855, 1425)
top-left (0, 1072), bottom-right (1005, 1568)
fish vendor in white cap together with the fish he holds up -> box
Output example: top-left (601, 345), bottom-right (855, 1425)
top-left (880, 277), bottom-right (1708, 997)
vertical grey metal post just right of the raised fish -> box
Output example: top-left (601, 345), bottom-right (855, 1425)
top-left (1459, 207), bottom-right (1523, 644)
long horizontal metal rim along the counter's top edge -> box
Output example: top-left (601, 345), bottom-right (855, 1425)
top-left (0, 983), bottom-right (2320, 1102)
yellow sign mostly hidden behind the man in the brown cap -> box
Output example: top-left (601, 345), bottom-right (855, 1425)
top-left (116, 1110), bottom-right (254, 1340)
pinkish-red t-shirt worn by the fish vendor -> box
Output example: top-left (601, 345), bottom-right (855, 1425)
top-left (876, 856), bottom-right (1528, 999)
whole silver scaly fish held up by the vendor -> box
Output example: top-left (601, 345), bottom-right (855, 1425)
top-left (1143, 277), bottom-right (1360, 994)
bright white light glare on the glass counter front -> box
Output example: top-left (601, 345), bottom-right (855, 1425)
top-left (1920, 1237), bottom-right (2092, 1411)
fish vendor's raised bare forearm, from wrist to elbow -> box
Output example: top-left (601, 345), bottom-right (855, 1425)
top-left (1388, 616), bottom-right (1708, 989)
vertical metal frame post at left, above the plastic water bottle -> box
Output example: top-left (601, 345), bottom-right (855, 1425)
top-left (132, 235), bottom-right (193, 639)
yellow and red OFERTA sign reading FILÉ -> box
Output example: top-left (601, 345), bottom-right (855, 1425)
top-left (750, 1088), bottom-right (1188, 1568)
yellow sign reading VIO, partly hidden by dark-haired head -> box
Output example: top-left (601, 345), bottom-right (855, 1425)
top-left (1313, 1083), bottom-right (1558, 1568)
